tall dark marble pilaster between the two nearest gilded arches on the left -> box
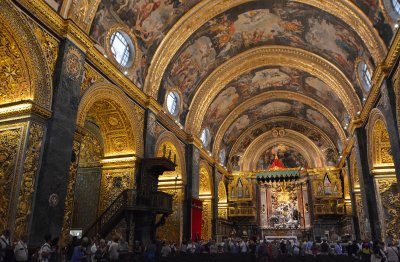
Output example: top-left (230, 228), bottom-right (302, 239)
top-left (30, 39), bottom-right (85, 245)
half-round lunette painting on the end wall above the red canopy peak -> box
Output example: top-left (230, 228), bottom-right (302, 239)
top-left (257, 143), bottom-right (308, 170)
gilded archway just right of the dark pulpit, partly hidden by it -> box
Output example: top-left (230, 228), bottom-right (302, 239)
top-left (156, 132), bottom-right (186, 245)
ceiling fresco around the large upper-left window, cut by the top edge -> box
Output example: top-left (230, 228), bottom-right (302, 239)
top-left (90, 0), bottom-right (199, 88)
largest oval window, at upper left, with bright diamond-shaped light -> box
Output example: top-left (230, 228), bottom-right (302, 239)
top-left (110, 31), bottom-right (133, 66)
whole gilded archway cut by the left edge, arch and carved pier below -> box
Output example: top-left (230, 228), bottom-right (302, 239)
top-left (0, 0), bottom-right (52, 239)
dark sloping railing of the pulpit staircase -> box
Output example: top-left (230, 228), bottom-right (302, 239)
top-left (84, 189), bottom-right (136, 236)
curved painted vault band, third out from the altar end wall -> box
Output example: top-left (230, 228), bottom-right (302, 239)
top-left (203, 66), bottom-right (349, 130)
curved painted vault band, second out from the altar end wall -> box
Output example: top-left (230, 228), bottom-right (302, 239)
top-left (210, 99), bottom-right (342, 156)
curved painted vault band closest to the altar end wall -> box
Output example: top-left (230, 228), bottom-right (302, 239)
top-left (225, 117), bottom-right (339, 166)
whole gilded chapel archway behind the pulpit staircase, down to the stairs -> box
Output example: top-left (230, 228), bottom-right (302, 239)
top-left (72, 84), bottom-right (141, 229)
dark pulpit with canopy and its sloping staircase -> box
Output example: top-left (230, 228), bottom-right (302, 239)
top-left (83, 157), bottom-right (176, 240)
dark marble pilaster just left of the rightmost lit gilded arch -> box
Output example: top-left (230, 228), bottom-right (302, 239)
top-left (355, 127), bottom-right (381, 240)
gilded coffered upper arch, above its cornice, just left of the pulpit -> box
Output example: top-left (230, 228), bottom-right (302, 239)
top-left (77, 83), bottom-right (143, 156)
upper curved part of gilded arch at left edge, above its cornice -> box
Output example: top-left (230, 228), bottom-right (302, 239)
top-left (0, 0), bottom-right (53, 110)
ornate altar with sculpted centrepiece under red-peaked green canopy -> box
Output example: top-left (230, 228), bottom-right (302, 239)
top-left (256, 157), bottom-right (310, 235)
